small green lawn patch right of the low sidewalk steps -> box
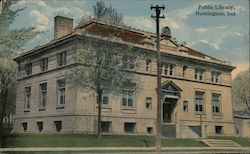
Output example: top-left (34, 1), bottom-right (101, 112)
top-left (210, 136), bottom-right (250, 147)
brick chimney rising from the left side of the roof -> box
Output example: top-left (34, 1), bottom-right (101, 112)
top-left (54, 16), bottom-right (73, 39)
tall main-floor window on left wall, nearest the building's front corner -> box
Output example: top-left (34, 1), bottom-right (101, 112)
top-left (57, 79), bottom-right (65, 106)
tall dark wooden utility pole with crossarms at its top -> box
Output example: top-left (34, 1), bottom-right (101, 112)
top-left (150, 5), bottom-right (165, 152)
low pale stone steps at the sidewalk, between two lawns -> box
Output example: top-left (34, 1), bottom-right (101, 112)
top-left (200, 139), bottom-right (240, 147)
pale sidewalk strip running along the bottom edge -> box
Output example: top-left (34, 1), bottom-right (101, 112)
top-left (0, 147), bottom-right (250, 153)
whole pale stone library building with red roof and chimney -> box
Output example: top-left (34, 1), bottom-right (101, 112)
top-left (14, 16), bottom-right (235, 138)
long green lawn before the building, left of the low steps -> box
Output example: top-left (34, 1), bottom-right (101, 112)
top-left (5, 133), bottom-right (206, 147)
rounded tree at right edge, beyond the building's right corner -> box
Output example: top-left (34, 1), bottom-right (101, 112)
top-left (232, 68), bottom-right (250, 112)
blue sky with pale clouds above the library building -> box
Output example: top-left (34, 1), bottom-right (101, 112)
top-left (12, 0), bottom-right (250, 78)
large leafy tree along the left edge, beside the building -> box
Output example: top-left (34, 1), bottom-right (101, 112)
top-left (0, 0), bottom-right (40, 147)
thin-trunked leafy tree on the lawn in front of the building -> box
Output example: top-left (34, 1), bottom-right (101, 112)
top-left (69, 35), bottom-right (140, 139)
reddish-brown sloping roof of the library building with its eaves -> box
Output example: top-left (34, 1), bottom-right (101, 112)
top-left (15, 19), bottom-right (231, 66)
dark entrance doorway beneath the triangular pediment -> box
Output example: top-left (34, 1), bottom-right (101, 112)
top-left (162, 99), bottom-right (177, 123)
